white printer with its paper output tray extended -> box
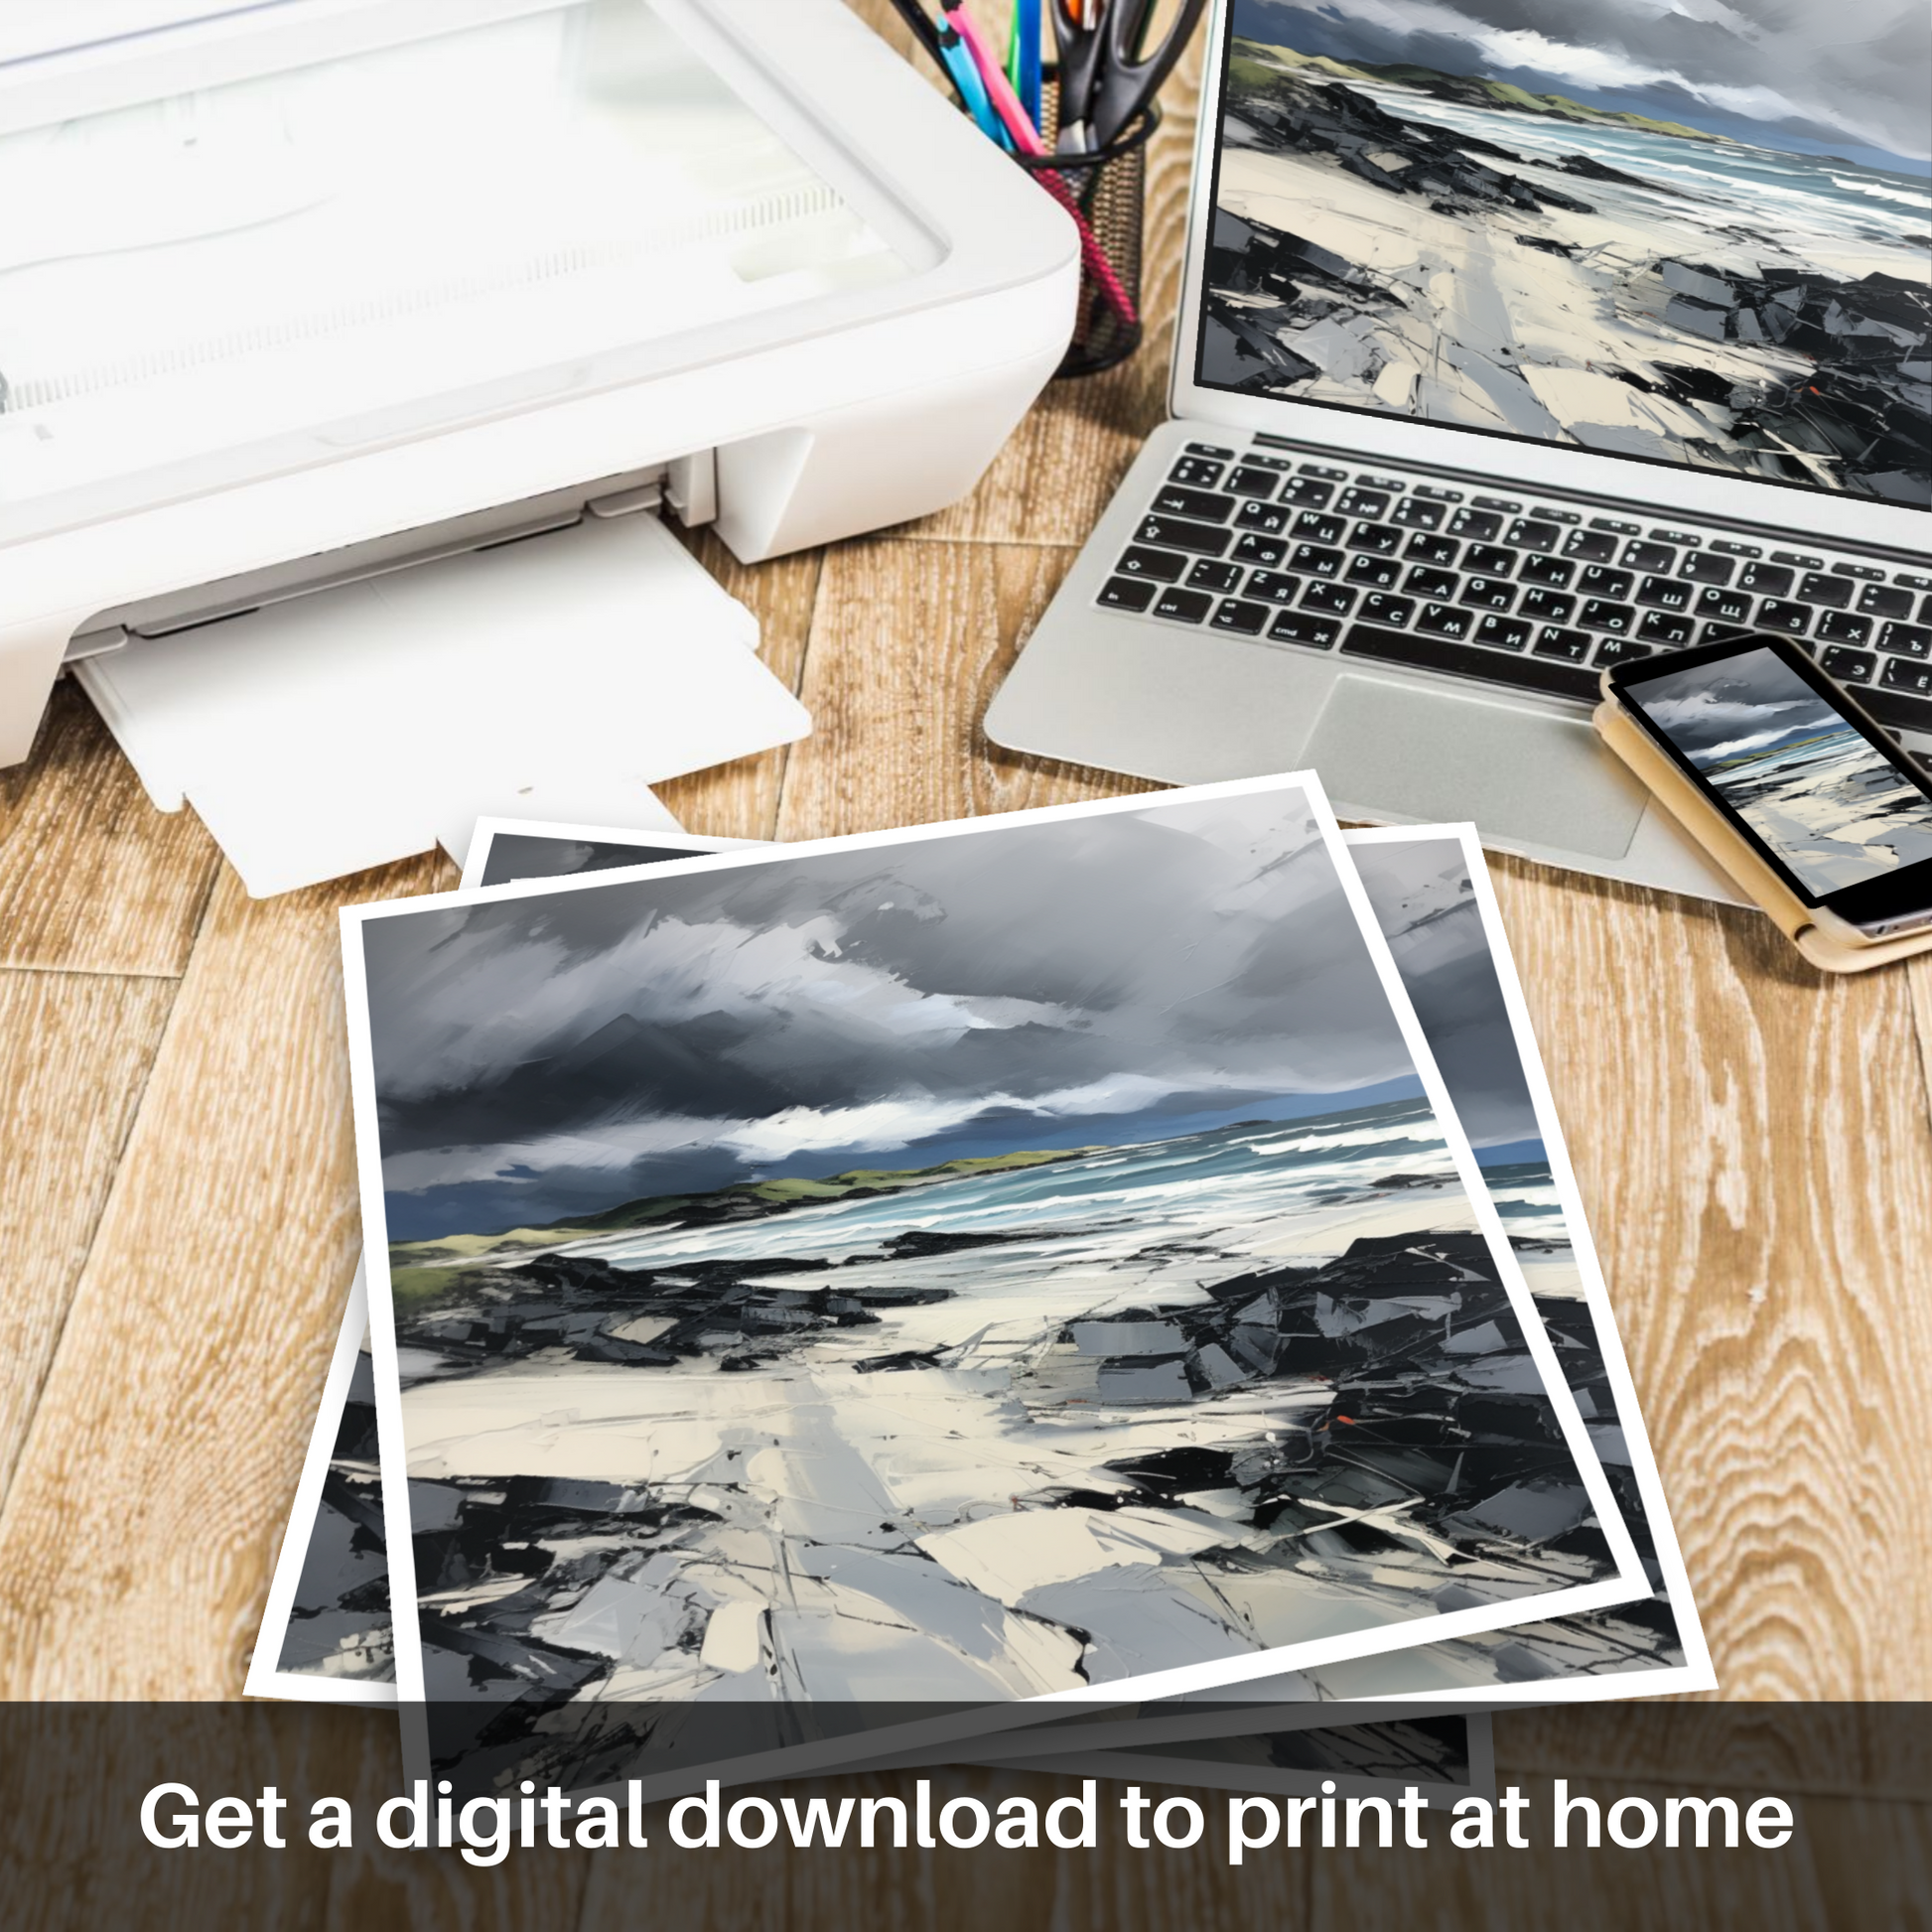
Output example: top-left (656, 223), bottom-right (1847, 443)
top-left (0, 0), bottom-right (1078, 891)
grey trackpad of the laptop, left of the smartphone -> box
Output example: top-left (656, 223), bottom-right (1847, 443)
top-left (1303, 676), bottom-right (1650, 858)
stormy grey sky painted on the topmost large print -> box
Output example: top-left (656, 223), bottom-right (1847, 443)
top-left (361, 790), bottom-right (1452, 1238)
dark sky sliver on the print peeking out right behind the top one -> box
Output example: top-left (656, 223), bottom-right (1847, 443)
top-left (1348, 839), bottom-right (1542, 1148)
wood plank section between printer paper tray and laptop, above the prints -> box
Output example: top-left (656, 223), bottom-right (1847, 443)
top-left (778, 537), bottom-right (1150, 839)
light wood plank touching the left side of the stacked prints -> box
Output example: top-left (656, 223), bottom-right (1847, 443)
top-left (0, 860), bottom-right (452, 1699)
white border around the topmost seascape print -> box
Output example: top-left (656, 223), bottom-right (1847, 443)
top-left (340, 772), bottom-right (1650, 1770)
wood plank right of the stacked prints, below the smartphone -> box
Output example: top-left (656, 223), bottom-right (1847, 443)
top-left (1495, 860), bottom-right (1932, 1699)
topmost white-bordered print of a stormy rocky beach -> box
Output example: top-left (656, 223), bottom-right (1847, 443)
top-left (345, 780), bottom-right (1640, 1777)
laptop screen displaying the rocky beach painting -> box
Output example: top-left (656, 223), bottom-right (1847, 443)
top-left (1196, 0), bottom-right (1932, 508)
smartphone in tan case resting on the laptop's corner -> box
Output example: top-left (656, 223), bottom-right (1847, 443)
top-left (1603, 633), bottom-right (1932, 943)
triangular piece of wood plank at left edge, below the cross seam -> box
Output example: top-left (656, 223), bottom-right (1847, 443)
top-left (0, 972), bottom-right (176, 1497)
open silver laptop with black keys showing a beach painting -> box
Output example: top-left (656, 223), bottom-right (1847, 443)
top-left (985, 0), bottom-right (1932, 900)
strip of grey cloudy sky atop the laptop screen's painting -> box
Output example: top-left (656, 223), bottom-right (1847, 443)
top-left (1234, 0), bottom-right (1932, 161)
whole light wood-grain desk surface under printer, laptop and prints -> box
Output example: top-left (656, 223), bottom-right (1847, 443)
top-left (0, 0), bottom-right (1932, 1924)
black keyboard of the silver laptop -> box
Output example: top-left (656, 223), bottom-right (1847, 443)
top-left (1097, 443), bottom-right (1932, 733)
